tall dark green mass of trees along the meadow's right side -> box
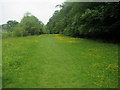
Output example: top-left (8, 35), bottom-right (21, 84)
top-left (47, 2), bottom-right (120, 39)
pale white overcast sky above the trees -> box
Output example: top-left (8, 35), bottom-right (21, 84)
top-left (0, 0), bottom-right (65, 24)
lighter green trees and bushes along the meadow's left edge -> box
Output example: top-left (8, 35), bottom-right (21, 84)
top-left (2, 12), bottom-right (45, 38)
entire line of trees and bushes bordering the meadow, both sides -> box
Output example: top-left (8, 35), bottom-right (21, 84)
top-left (0, 2), bottom-right (120, 40)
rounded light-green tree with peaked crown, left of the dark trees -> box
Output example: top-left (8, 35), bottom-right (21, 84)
top-left (20, 13), bottom-right (43, 35)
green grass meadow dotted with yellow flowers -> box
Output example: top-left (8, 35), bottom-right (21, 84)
top-left (3, 34), bottom-right (118, 88)
